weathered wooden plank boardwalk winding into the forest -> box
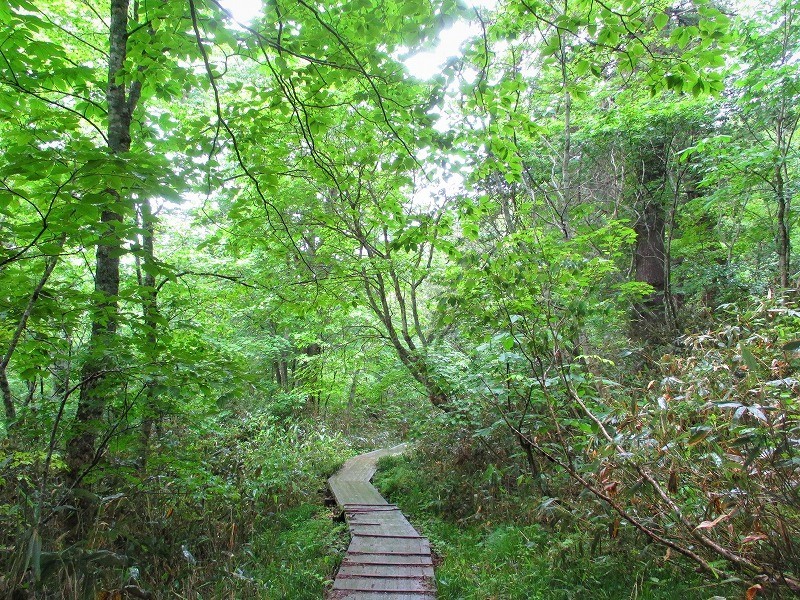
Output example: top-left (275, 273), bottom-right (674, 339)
top-left (328, 445), bottom-right (436, 600)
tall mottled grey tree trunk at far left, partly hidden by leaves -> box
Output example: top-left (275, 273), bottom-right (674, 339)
top-left (67, 0), bottom-right (138, 485)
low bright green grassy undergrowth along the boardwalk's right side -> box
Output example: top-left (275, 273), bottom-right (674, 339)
top-left (374, 453), bottom-right (741, 600)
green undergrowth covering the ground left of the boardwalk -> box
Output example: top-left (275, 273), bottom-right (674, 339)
top-left (0, 414), bottom-right (356, 600)
